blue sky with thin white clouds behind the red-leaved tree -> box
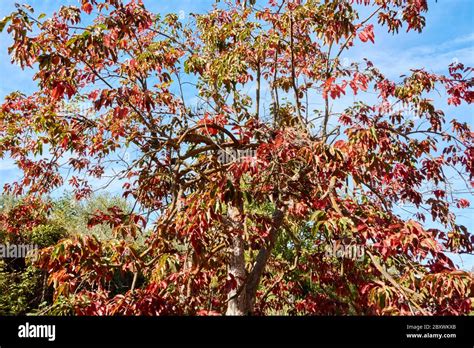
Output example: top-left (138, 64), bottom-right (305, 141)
top-left (0, 0), bottom-right (474, 269)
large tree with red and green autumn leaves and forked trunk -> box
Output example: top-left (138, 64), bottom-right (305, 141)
top-left (0, 0), bottom-right (474, 315)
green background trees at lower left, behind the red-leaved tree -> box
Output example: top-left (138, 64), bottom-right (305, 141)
top-left (0, 194), bottom-right (133, 315)
